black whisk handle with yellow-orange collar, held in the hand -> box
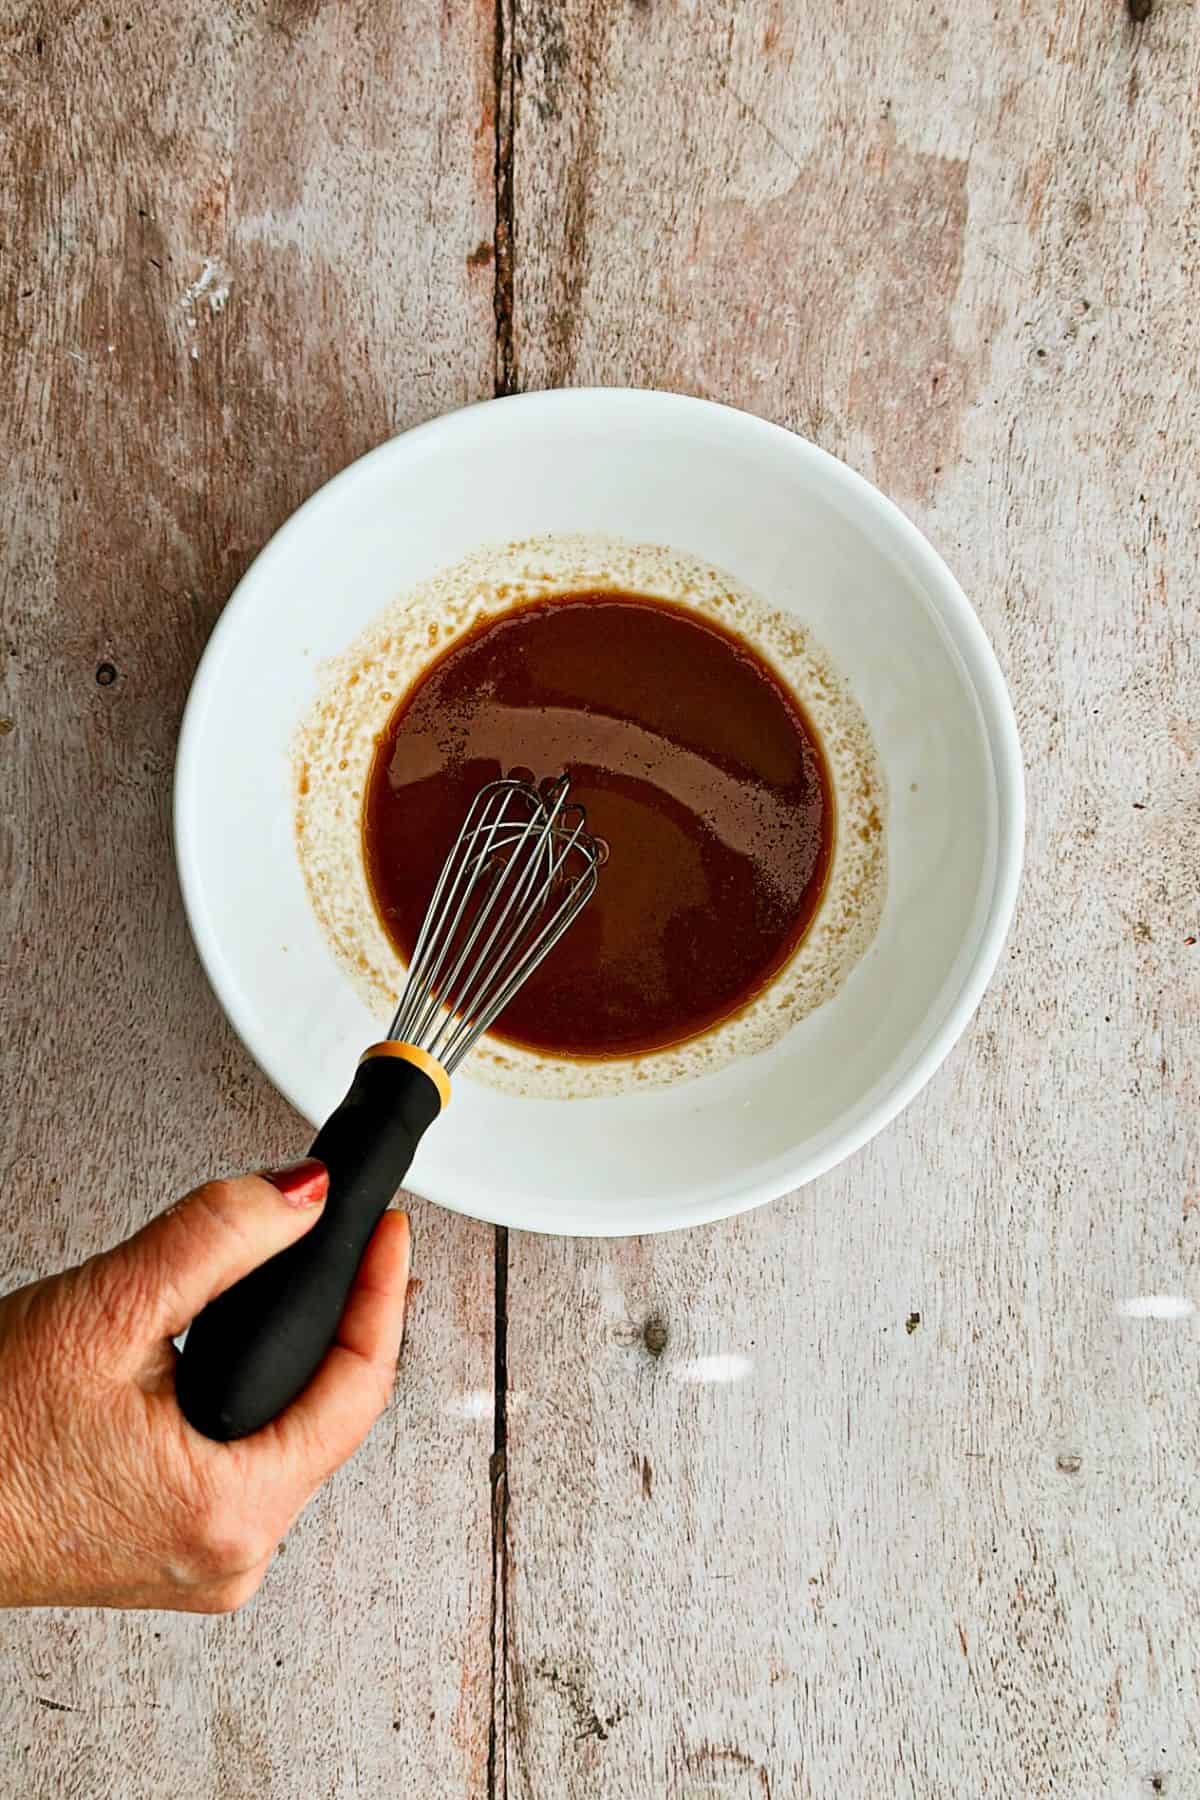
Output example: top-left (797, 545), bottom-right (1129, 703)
top-left (176, 1042), bottom-right (450, 1442)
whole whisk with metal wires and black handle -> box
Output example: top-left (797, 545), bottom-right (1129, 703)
top-left (175, 770), bottom-right (606, 1440)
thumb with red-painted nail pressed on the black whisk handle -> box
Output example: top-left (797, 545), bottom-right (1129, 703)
top-left (95, 1157), bottom-right (329, 1337)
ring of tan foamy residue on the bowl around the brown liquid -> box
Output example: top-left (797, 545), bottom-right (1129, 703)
top-left (293, 535), bottom-right (887, 1100)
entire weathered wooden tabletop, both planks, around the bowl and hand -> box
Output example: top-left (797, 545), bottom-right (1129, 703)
top-left (0, 0), bottom-right (1200, 1800)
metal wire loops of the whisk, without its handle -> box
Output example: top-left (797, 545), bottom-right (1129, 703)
top-left (389, 776), bottom-right (606, 1075)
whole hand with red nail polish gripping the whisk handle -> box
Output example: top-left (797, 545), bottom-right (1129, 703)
top-left (0, 1161), bottom-right (408, 1613)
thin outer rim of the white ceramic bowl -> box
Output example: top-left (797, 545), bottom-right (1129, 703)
top-left (171, 387), bottom-right (1025, 1238)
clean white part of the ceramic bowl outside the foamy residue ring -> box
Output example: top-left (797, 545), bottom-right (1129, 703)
top-left (175, 389), bottom-right (1024, 1235)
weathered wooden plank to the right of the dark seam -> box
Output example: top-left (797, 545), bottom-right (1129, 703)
top-left (506, 0), bottom-right (1200, 1800)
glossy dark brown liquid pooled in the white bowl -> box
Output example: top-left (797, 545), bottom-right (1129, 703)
top-left (363, 592), bottom-right (833, 1057)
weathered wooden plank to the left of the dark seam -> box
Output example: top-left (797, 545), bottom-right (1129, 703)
top-left (0, 0), bottom-right (495, 1800)
